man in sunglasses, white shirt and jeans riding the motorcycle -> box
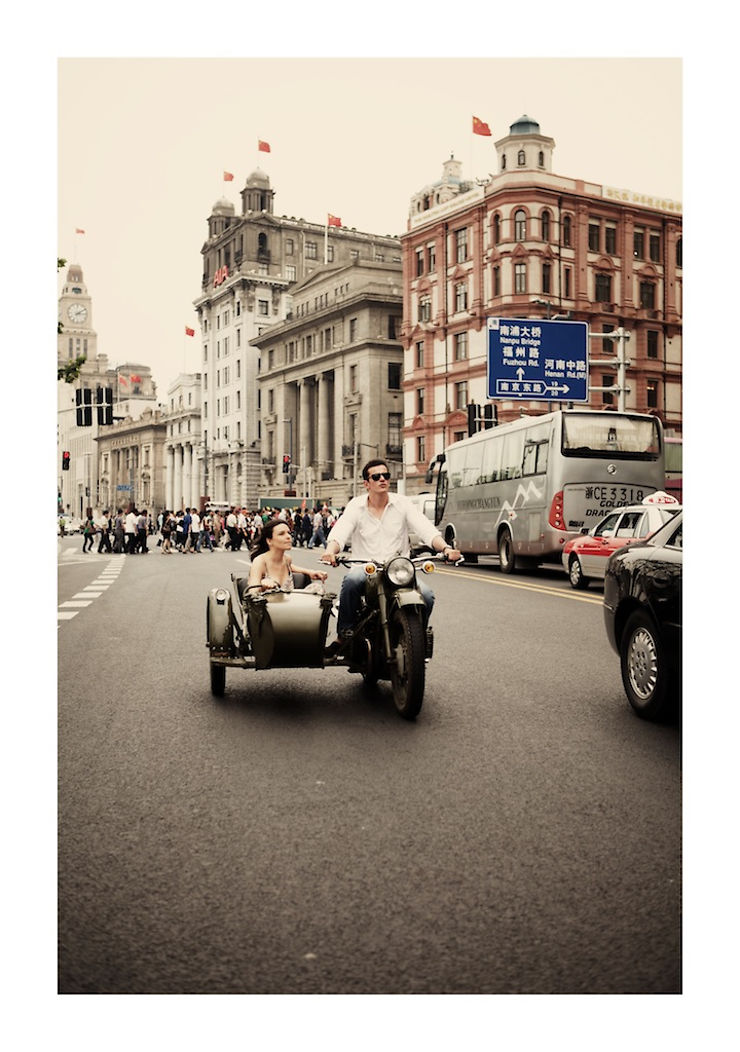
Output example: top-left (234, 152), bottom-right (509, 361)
top-left (321, 460), bottom-right (462, 655)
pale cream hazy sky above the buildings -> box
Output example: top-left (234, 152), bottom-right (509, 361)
top-left (58, 58), bottom-right (683, 402)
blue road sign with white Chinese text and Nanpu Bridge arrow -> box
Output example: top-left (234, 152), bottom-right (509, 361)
top-left (487, 318), bottom-right (588, 402)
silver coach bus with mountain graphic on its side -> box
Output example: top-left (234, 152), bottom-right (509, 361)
top-left (426, 409), bottom-right (665, 573)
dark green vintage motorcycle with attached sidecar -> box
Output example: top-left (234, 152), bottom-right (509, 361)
top-left (205, 555), bottom-right (454, 720)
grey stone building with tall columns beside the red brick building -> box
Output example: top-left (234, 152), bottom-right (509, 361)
top-left (253, 260), bottom-right (403, 506)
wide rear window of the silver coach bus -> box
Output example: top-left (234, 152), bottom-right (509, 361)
top-left (562, 413), bottom-right (660, 461)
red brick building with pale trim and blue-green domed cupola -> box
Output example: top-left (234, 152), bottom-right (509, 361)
top-left (401, 117), bottom-right (682, 492)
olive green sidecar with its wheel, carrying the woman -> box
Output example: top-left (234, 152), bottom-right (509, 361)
top-left (205, 573), bottom-right (337, 697)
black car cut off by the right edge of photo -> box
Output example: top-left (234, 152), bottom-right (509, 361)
top-left (603, 511), bottom-right (683, 720)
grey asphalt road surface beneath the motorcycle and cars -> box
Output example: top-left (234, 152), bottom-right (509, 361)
top-left (58, 539), bottom-right (681, 994)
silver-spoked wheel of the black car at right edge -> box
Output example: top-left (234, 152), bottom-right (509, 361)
top-left (620, 610), bottom-right (675, 720)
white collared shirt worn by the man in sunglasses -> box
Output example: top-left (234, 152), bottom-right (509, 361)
top-left (326, 493), bottom-right (441, 562)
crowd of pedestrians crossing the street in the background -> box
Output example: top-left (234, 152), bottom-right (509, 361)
top-left (69, 505), bottom-right (336, 555)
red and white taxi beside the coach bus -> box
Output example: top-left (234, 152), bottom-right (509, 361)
top-left (562, 490), bottom-right (681, 589)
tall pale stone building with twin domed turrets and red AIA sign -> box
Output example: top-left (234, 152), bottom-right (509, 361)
top-left (193, 168), bottom-right (401, 505)
